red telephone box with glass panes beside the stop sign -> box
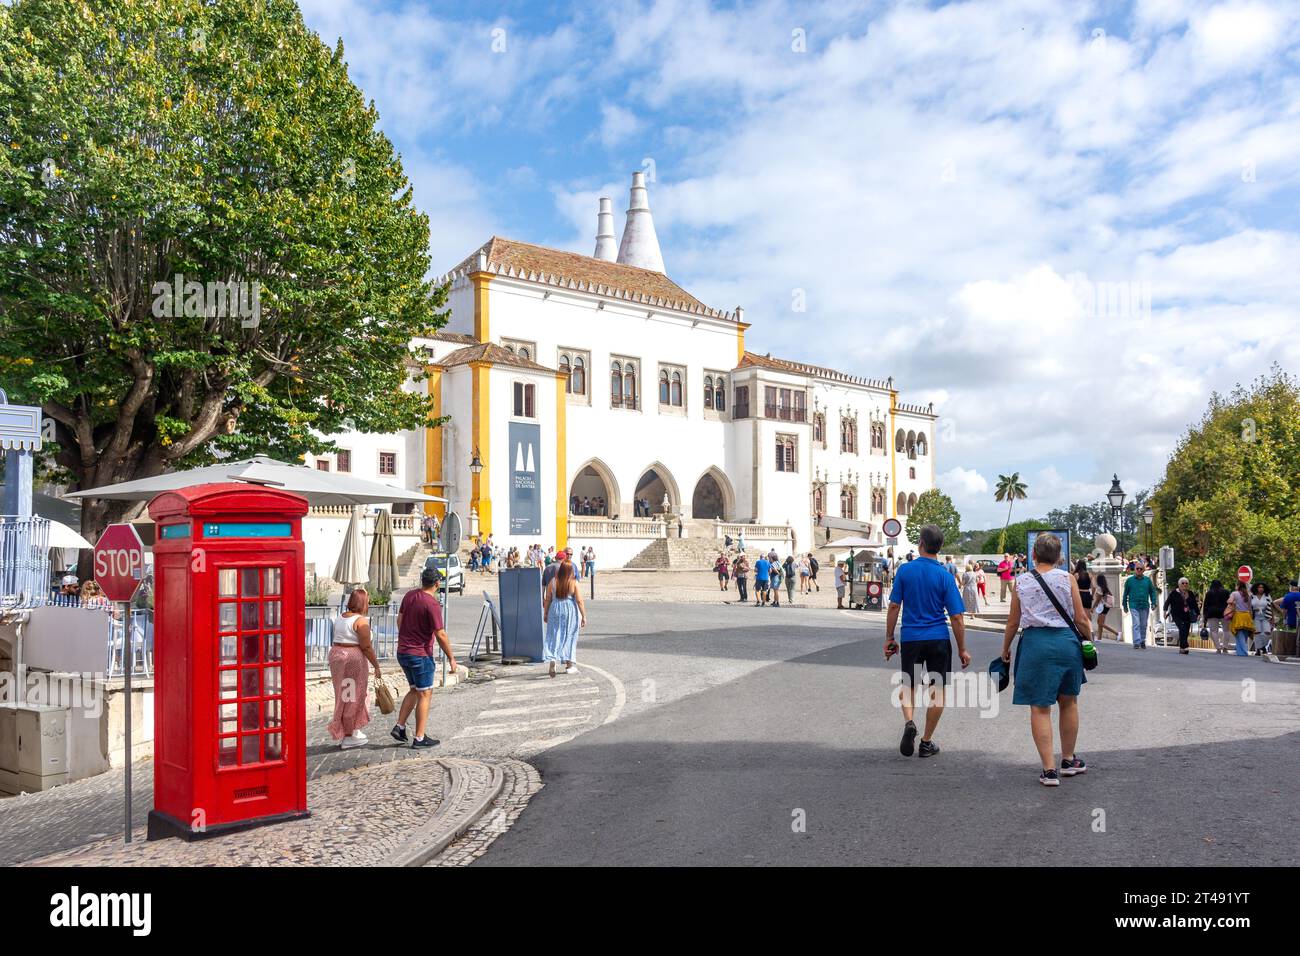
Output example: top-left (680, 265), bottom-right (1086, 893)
top-left (148, 483), bottom-right (308, 840)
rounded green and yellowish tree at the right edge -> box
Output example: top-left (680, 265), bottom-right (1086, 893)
top-left (1151, 367), bottom-right (1300, 592)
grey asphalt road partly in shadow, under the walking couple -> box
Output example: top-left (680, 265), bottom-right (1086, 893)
top-left (480, 602), bottom-right (1300, 866)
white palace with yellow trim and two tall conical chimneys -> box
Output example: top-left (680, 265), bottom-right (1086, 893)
top-left (306, 173), bottom-right (936, 568)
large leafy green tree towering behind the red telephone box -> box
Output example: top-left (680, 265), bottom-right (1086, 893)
top-left (0, 0), bottom-right (445, 548)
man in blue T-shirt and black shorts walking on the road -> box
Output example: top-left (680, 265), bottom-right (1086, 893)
top-left (885, 524), bottom-right (971, 757)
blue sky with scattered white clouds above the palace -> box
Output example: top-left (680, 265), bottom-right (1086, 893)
top-left (302, 0), bottom-right (1300, 527)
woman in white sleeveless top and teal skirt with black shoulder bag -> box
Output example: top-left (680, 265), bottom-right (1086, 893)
top-left (1002, 535), bottom-right (1092, 787)
